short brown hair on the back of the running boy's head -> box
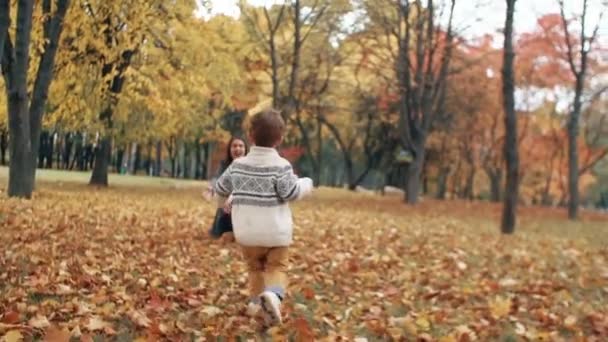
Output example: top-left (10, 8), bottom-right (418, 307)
top-left (249, 108), bottom-right (285, 147)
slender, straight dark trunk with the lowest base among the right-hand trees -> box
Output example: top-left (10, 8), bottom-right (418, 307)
top-left (501, 0), bottom-right (519, 234)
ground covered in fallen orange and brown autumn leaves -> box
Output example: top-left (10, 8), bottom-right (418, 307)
top-left (0, 170), bottom-right (608, 341)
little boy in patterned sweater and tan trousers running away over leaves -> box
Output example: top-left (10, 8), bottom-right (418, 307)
top-left (215, 110), bottom-right (313, 325)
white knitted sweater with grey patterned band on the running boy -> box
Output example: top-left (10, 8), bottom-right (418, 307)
top-left (215, 146), bottom-right (313, 247)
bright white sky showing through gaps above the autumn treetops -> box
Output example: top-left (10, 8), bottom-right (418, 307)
top-left (205, 0), bottom-right (608, 39)
